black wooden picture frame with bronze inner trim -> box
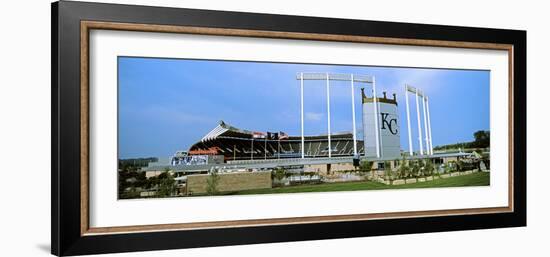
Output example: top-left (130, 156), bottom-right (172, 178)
top-left (51, 1), bottom-right (526, 255)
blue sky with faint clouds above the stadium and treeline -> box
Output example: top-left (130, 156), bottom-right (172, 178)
top-left (118, 57), bottom-right (490, 158)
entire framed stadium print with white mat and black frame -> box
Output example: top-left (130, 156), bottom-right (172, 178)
top-left (52, 1), bottom-right (526, 255)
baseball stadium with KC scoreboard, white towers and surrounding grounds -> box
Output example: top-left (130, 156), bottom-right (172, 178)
top-left (125, 72), bottom-right (488, 197)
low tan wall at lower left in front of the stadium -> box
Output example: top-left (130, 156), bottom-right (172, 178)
top-left (186, 172), bottom-right (271, 195)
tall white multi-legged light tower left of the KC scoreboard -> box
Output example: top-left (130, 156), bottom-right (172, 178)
top-left (296, 72), bottom-right (380, 158)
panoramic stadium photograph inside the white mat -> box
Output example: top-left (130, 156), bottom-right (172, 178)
top-left (117, 56), bottom-right (490, 200)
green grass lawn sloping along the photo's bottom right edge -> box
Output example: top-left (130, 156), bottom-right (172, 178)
top-left (229, 172), bottom-right (489, 195)
